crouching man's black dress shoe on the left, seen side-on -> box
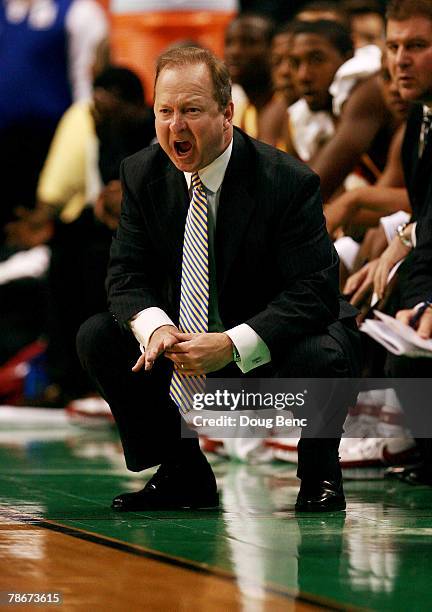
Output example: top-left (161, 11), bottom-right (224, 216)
top-left (111, 460), bottom-right (219, 512)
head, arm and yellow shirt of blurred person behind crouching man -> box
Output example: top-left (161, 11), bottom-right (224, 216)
top-left (8, 67), bottom-right (154, 237)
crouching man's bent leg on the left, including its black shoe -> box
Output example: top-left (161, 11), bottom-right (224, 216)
top-left (77, 313), bottom-right (217, 510)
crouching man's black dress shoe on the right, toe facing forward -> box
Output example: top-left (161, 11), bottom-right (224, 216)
top-left (295, 480), bottom-right (346, 512)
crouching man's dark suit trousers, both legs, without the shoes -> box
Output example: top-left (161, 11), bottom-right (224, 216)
top-left (77, 313), bottom-right (360, 479)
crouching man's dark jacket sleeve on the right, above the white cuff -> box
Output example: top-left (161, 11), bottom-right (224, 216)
top-left (246, 172), bottom-right (340, 354)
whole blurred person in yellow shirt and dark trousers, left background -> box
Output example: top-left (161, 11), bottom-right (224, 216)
top-left (2, 67), bottom-right (155, 405)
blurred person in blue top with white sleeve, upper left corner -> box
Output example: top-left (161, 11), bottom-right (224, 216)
top-left (0, 0), bottom-right (108, 234)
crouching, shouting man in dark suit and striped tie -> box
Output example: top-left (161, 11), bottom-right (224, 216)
top-left (78, 47), bottom-right (358, 511)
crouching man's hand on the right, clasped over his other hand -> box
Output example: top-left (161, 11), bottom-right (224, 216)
top-left (165, 333), bottom-right (233, 376)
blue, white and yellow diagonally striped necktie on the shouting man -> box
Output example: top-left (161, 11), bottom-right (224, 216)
top-left (170, 172), bottom-right (209, 414)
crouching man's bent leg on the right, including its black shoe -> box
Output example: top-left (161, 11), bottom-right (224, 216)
top-left (276, 321), bottom-right (360, 511)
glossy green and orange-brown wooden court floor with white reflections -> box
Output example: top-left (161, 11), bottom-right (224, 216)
top-left (0, 407), bottom-right (432, 612)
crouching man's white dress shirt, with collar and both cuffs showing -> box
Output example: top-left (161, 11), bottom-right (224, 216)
top-left (130, 141), bottom-right (271, 373)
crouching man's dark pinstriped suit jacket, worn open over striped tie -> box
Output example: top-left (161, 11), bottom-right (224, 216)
top-left (107, 129), bottom-right (355, 355)
